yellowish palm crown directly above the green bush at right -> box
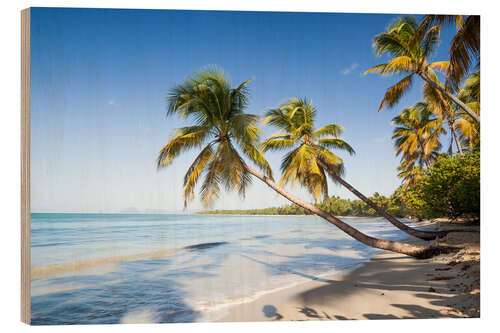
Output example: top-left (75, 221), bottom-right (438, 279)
top-left (392, 102), bottom-right (445, 171)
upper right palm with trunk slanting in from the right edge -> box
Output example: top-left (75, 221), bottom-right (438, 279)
top-left (365, 16), bottom-right (480, 124)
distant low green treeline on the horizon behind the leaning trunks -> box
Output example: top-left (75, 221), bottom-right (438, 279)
top-left (196, 191), bottom-right (411, 217)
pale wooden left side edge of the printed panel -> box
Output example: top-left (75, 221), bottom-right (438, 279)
top-left (21, 8), bottom-right (31, 324)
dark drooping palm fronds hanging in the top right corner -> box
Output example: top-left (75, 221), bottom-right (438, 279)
top-left (418, 15), bottom-right (481, 90)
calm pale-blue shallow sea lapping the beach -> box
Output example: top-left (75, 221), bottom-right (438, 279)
top-left (31, 213), bottom-right (412, 325)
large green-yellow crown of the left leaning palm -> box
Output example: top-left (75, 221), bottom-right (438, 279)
top-left (157, 67), bottom-right (272, 207)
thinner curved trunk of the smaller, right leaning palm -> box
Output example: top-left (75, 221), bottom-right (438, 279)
top-left (318, 159), bottom-right (448, 240)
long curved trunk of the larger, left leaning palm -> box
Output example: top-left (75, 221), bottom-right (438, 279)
top-left (245, 165), bottom-right (456, 259)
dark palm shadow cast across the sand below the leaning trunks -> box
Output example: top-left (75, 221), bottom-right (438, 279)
top-left (288, 253), bottom-right (470, 320)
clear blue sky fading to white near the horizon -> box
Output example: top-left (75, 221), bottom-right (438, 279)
top-left (31, 8), bottom-right (453, 212)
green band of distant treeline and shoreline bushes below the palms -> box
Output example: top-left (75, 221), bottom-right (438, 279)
top-left (199, 152), bottom-right (480, 223)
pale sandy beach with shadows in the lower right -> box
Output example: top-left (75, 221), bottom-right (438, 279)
top-left (219, 220), bottom-right (480, 322)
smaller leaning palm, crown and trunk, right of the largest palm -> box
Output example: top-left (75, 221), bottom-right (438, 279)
top-left (262, 98), bottom-right (444, 240)
